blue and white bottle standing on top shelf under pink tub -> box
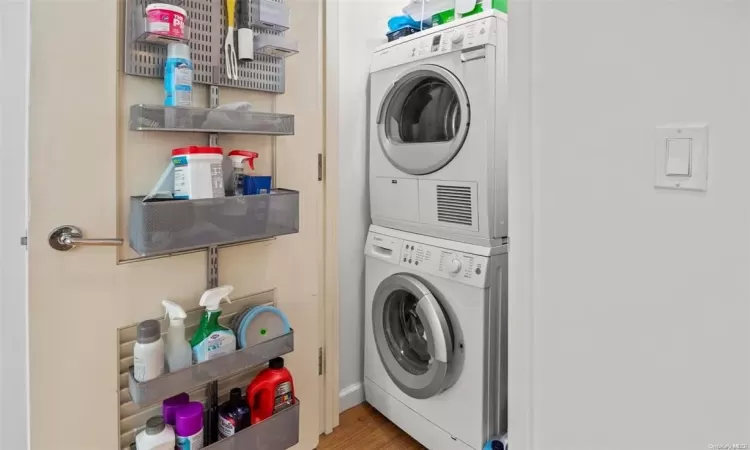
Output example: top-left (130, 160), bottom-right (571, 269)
top-left (164, 42), bottom-right (193, 106)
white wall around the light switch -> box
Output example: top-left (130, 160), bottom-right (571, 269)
top-left (510, 0), bottom-right (750, 450)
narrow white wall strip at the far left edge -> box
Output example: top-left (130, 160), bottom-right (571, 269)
top-left (0, 1), bottom-right (31, 450)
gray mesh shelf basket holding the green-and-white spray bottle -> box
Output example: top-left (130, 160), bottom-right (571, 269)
top-left (128, 331), bottom-right (294, 408)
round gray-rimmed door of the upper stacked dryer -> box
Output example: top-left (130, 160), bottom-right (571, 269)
top-left (377, 65), bottom-right (470, 175)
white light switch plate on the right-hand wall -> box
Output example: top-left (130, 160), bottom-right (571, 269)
top-left (654, 123), bottom-right (708, 191)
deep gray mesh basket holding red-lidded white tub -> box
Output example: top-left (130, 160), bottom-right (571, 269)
top-left (129, 189), bottom-right (299, 256)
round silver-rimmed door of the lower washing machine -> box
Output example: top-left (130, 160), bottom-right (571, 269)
top-left (372, 274), bottom-right (453, 399)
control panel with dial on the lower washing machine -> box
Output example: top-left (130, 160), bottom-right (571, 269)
top-left (399, 241), bottom-right (489, 287)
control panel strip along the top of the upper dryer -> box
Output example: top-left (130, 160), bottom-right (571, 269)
top-left (370, 17), bottom-right (497, 72)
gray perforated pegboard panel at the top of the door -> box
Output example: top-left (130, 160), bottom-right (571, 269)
top-left (124, 0), bottom-right (285, 93)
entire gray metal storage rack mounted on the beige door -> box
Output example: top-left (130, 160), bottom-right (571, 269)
top-left (125, 0), bottom-right (299, 442)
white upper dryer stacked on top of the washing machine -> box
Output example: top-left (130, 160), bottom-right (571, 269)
top-left (368, 11), bottom-right (508, 246)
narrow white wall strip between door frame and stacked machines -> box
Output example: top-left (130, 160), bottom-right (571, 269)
top-left (328, 0), bottom-right (407, 410)
